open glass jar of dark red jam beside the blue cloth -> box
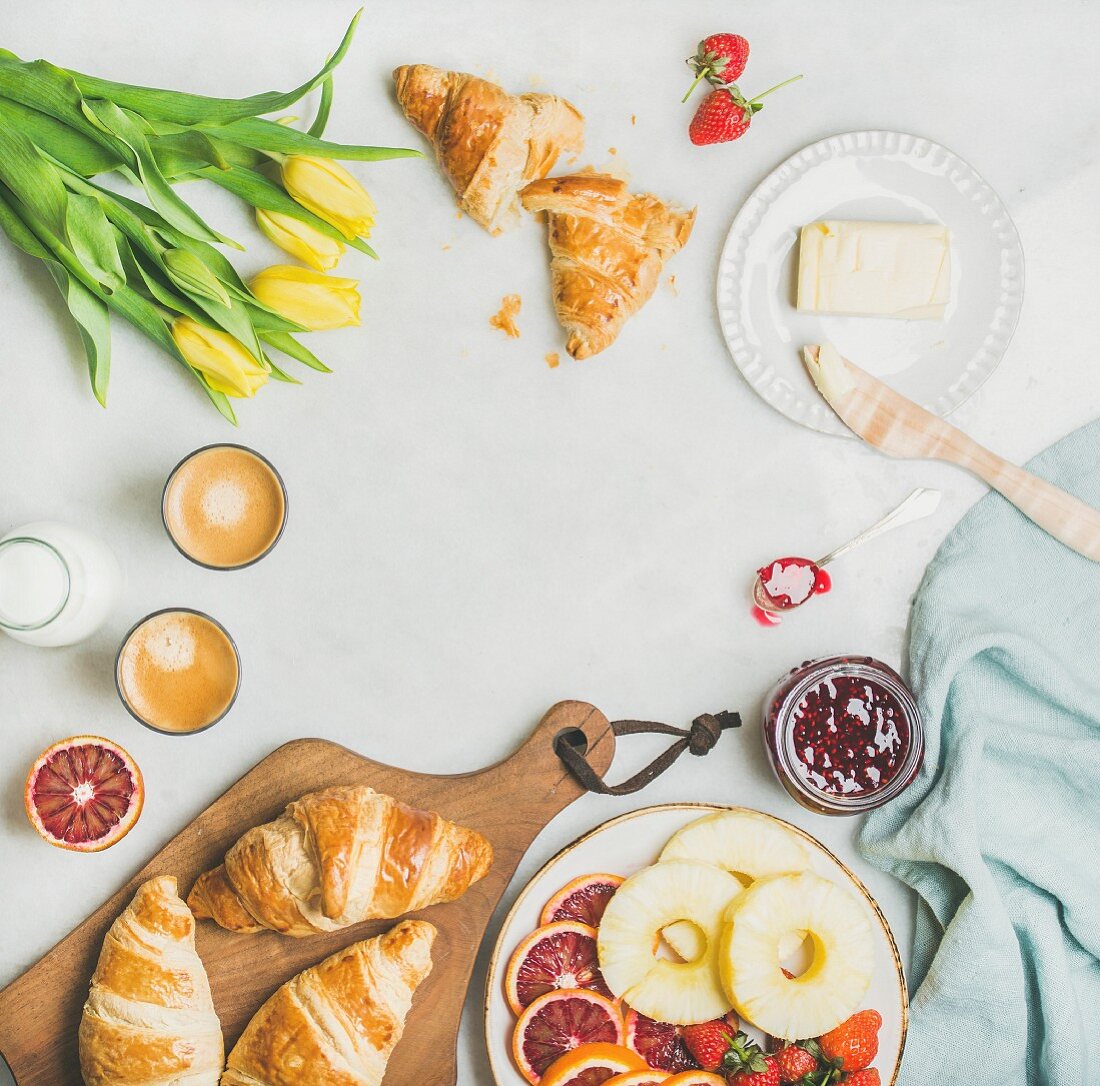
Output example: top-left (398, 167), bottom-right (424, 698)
top-left (763, 656), bottom-right (924, 814)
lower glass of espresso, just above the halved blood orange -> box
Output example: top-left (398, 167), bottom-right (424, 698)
top-left (114, 607), bottom-right (241, 735)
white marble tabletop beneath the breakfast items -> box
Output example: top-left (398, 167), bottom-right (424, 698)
top-left (0, 0), bottom-right (1100, 1086)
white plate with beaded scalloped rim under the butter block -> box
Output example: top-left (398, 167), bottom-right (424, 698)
top-left (718, 132), bottom-right (1024, 437)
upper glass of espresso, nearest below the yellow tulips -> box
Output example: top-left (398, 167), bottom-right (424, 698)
top-left (161, 445), bottom-right (287, 570)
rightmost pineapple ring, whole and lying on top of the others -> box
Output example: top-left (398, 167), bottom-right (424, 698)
top-left (718, 871), bottom-right (875, 1040)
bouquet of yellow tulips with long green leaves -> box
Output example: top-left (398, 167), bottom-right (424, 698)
top-left (0, 12), bottom-right (419, 423)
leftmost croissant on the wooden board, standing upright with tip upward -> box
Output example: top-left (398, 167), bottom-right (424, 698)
top-left (79, 877), bottom-right (224, 1086)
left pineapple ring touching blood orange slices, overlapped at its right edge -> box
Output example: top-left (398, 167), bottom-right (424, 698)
top-left (596, 860), bottom-right (741, 1025)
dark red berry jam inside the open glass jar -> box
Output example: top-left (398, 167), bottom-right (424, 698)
top-left (791, 676), bottom-right (910, 796)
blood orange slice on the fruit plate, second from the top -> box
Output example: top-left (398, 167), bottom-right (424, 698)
top-left (504, 921), bottom-right (612, 1014)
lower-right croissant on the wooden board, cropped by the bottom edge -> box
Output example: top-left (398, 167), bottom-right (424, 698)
top-left (221, 920), bottom-right (436, 1086)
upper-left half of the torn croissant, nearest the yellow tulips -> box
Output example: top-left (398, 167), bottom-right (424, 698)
top-left (394, 64), bottom-right (584, 234)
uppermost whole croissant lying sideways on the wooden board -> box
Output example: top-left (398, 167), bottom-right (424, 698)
top-left (187, 786), bottom-right (493, 936)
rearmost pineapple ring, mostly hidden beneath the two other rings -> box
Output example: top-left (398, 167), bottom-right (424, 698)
top-left (658, 811), bottom-right (810, 962)
